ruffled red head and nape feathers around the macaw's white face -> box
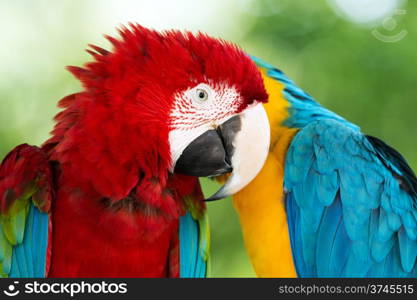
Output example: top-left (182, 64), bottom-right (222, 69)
top-left (44, 25), bottom-right (267, 214)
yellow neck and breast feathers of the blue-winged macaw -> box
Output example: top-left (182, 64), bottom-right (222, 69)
top-left (233, 70), bottom-right (297, 277)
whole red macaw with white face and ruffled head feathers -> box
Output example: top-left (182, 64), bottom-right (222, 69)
top-left (0, 25), bottom-right (269, 277)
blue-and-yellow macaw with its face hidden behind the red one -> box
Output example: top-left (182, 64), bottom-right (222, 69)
top-left (228, 58), bottom-right (417, 277)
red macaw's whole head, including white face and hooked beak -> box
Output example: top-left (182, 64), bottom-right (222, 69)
top-left (48, 25), bottom-right (269, 204)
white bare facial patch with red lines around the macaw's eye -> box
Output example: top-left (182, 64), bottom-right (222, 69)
top-left (169, 83), bottom-right (241, 170)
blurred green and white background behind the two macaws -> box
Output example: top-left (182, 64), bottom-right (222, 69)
top-left (0, 0), bottom-right (417, 277)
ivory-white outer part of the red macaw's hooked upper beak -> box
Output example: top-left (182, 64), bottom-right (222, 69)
top-left (206, 103), bottom-right (270, 201)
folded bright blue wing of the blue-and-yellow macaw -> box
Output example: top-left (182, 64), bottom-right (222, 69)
top-left (284, 119), bottom-right (417, 277)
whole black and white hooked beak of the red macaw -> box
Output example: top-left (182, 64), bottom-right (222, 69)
top-left (174, 104), bottom-right (270, 201)
